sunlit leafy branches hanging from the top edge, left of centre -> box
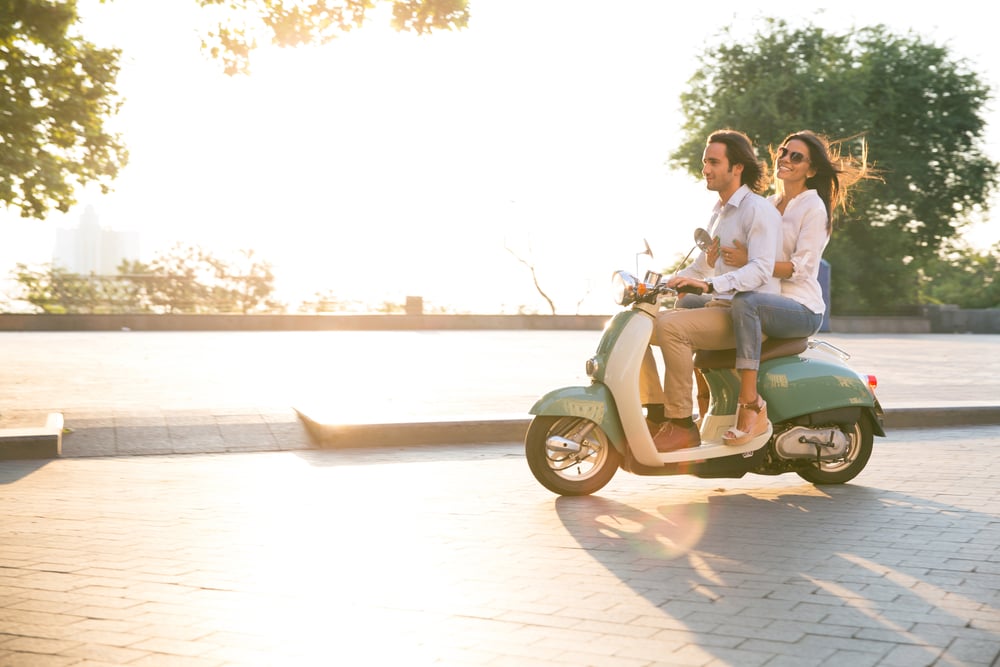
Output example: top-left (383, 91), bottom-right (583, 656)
top-left (198, 0), bottom-right (469, 75)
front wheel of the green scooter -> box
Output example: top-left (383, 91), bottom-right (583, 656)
top-left (524, 415), bottom-right (621, 496)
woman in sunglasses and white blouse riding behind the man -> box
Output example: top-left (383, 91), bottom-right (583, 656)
top-left (720, 130), bottom-right (871, 445)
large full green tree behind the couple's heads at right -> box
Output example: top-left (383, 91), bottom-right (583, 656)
top-left (670, 19), bottom-right (998, 314)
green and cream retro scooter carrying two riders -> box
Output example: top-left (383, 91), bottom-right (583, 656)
top-left (524, 252), bottom-right (885, 496)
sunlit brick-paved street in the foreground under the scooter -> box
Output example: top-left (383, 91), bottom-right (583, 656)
top-left (0, 427), bottom-right (1000, 667)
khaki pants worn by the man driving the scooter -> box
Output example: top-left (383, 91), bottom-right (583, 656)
top-left (639, 299), bottom-right (736, 419)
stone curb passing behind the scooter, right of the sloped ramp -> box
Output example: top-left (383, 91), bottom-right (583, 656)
top-left (298, 406), bottom-right (1000, 449)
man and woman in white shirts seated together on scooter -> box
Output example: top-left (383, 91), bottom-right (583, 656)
top-left (640, 130), bottom-right (868, 452)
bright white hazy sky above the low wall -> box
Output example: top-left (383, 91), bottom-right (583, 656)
top-left (0, 0), bottom-right (1000, 314)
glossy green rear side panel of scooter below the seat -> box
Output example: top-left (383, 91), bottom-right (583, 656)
top-left (758, 356), bottom-right (875, 422)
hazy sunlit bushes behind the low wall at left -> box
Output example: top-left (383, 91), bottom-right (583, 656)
top-left (14, 244), bottom-right (284, 315)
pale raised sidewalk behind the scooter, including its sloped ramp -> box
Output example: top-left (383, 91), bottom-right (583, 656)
top-left (0, 331), bottom-right (1000, 457)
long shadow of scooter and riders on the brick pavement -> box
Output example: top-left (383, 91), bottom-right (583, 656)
top-left (555, 485), bottom-right (1000, 665)
